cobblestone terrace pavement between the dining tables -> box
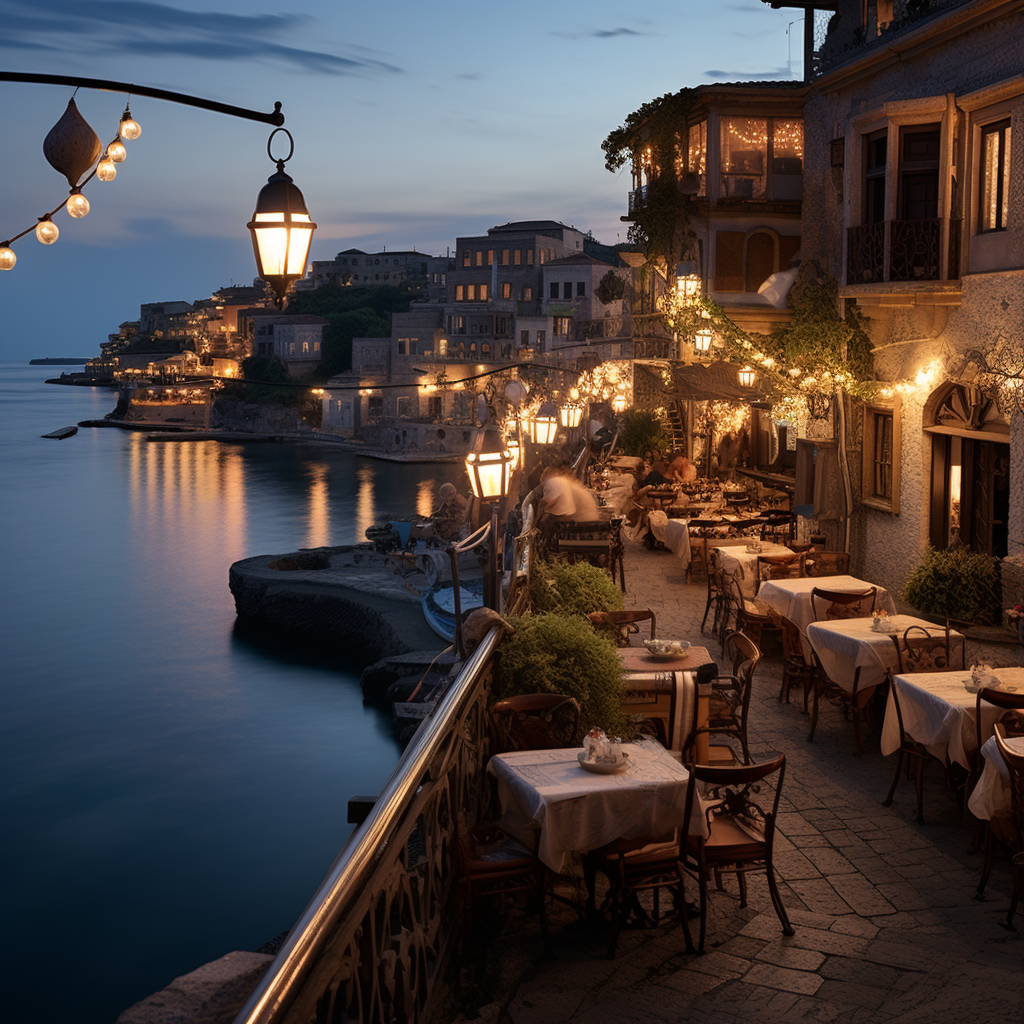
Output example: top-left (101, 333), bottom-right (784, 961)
top-left (462, 546), bottom-right (1024, 1024)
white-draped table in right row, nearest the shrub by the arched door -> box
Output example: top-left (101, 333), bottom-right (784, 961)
top-left (806, 610), bottom-right (963, 700)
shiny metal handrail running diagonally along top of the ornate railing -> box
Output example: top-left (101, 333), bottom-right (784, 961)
top-left (234, 629), bottom-right (501, 1024)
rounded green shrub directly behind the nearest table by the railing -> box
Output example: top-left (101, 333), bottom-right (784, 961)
top-left (494, 612), bottom-right (635, 737)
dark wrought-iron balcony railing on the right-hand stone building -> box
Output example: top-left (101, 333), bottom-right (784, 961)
top-left (846, 217), bottom-right (959, 285)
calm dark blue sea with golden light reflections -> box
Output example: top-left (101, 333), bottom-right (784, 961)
top-left (0, 362), bottom-right (462, 1024)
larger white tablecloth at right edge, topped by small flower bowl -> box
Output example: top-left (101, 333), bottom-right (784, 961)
top-left (882, 663), bottom-right (1024, 768)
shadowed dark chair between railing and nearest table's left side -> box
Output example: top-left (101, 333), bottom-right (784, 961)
top-left (459, 824), bottom-right (551, 955)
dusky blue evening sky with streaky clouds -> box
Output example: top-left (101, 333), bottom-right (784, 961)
top-left (0, 0), bottom-right (803, 360)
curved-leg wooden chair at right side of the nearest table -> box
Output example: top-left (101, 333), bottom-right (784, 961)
top-left (682, 755), bottom-right (794, 952)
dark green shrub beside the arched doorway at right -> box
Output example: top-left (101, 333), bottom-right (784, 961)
top-left (903, 547), bottom-right (1000, 623)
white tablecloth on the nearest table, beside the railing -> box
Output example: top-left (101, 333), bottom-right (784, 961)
top-left (487, 742), bottom-right (707, 871)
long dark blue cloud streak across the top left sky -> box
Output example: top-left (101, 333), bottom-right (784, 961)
top-left (0, 0), bottom-right (402, 75)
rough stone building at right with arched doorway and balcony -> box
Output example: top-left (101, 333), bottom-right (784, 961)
top-left (801, 0), bottom-right (1024, 600)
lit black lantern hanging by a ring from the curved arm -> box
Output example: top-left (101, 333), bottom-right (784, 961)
top-left (247, 128), bottom-right (316, 308)
